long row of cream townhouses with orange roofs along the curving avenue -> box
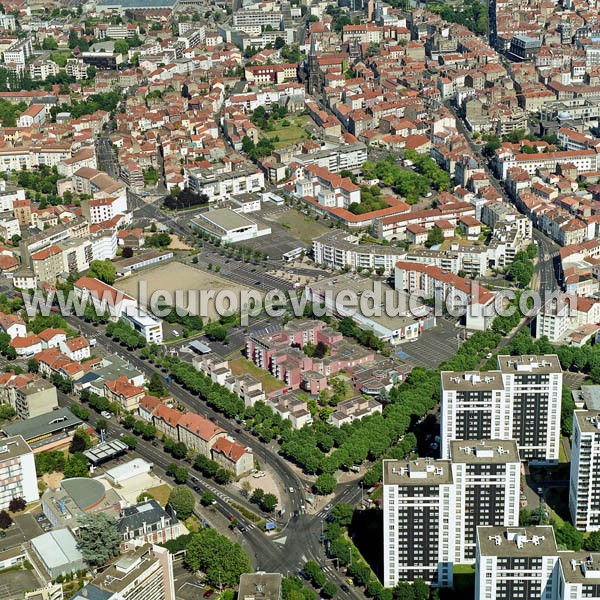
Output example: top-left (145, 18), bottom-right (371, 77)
top-left (137, 396), bottom-right (254, 477)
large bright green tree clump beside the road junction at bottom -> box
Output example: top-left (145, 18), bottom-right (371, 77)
top-left (185, 528), bottom-right (251, 587)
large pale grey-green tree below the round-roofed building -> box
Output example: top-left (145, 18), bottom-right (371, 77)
top-left (77, 512), bottom-right (121, 566)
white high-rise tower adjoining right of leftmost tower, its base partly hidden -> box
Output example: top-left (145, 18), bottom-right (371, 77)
top-left (450, 440), bottom-right (521, 564)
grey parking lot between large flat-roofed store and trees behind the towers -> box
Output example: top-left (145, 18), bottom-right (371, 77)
top-left (398, 317), bottom-right (465, 369)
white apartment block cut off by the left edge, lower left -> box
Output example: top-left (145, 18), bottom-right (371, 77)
top-left (0, 435), bottom-right (40, 510)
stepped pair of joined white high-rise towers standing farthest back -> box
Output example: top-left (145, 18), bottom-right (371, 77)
top-left (441, 354), bottom-right (562, 463)
